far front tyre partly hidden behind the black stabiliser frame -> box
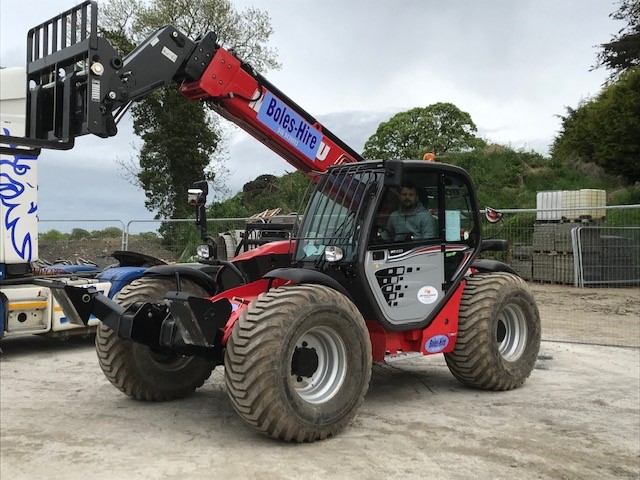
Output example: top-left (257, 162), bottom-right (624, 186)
top-left (96, 277), bottom-right (215, 401)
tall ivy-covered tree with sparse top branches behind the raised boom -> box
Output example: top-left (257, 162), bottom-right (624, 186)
top-left (101, 0), bottom-right (279, 218)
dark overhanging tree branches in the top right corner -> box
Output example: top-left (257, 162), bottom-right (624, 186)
top-left (596, 0), bottom-right (640, 79)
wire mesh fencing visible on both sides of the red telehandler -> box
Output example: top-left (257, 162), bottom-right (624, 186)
top-left (40, 205), bottom-right (640, 347)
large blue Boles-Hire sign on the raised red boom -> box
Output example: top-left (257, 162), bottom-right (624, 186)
top-left (258, 92), bottom-right (322, 160)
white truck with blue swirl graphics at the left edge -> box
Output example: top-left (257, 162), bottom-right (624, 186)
top-left (0, 68), bottom-right (110, 338)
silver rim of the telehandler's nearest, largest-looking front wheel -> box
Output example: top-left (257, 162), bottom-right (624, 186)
top-left (291, 327), bottom-right (347, 403)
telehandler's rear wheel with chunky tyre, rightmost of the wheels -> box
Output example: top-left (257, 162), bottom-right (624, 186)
top-left (444, 272), bottom-right (541, 390)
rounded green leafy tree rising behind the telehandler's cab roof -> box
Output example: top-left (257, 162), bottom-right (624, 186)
top-left (362, 103), bottom-right (485, 159)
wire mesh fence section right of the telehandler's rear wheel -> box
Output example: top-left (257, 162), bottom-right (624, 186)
top-left (483, 205), bottom-right (640, 348)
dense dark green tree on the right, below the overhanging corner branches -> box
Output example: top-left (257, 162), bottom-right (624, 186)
top-left (551, 66), bottom-right (640, 182)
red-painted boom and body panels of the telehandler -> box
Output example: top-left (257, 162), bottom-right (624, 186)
top-left (180, 42), bottom-right (465, 361)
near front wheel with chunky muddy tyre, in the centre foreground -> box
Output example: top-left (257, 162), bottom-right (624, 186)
top-left (225, 285), bottom-right (372, 442)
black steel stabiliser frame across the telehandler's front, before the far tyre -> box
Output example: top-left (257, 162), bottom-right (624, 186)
top-left (35, 280), bottom-right (231, 358)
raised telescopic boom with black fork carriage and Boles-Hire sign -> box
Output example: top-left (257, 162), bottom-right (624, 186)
top-left (2, 1), bottom-right (362, 177)
